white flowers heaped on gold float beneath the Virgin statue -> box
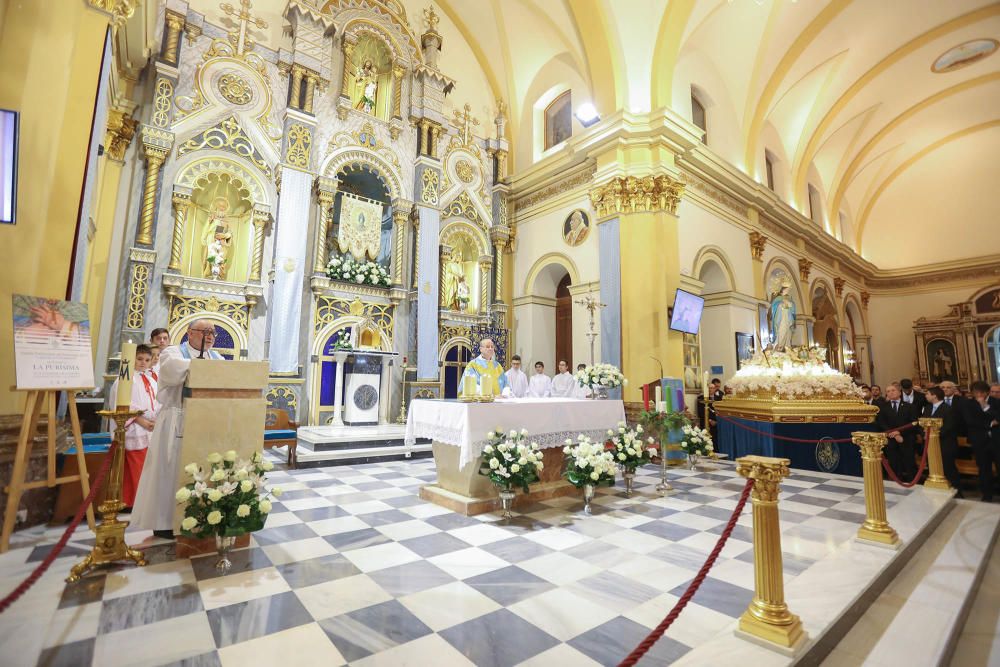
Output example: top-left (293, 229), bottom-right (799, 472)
top-left (726, 347), bottom-right (862, 400)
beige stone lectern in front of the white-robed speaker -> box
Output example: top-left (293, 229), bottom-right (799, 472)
top-left (174, 359), bottom-right (270, 534)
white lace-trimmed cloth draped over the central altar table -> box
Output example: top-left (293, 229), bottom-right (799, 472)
top-left (405, 398), bottom-right (625, 468)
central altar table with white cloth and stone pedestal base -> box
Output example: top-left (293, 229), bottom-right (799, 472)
top-left (405, 398), bottom-right (625, 516)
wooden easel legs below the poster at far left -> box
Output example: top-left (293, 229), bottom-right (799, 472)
top-left (0, 387), bottom-right (96, 553)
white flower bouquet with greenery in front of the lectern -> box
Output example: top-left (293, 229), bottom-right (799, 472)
top-left (176, 450), bottom-right (281, 538)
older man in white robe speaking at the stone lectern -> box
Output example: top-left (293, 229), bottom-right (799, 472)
top-left (132, 319), bottom-right (223, 539)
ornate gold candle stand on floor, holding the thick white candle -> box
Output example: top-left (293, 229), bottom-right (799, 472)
top-left (66, 406), bottom-right (146, 583)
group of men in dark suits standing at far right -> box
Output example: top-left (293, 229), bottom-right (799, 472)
top-left (862, 379), bottom-right (1000, 502)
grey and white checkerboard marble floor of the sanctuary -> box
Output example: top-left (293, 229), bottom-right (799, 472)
top-left (0, 460), bottom-right (907, 667)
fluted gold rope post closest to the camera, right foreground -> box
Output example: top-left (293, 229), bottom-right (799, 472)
top-left (736, 456), bottom-right (805, 648)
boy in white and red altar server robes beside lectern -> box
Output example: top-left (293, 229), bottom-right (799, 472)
top-left (111, 345), bottom-right (160, 507)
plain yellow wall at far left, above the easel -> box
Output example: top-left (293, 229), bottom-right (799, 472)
top-left (0, 1), bottom-right (108, 414)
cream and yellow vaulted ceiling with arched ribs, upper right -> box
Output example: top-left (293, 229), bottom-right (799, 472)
top-left (192, 0), bottom-right (1000, 269)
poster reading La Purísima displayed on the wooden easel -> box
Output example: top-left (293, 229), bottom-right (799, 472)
top-left (13, 294), bottom-right (94, 390)
